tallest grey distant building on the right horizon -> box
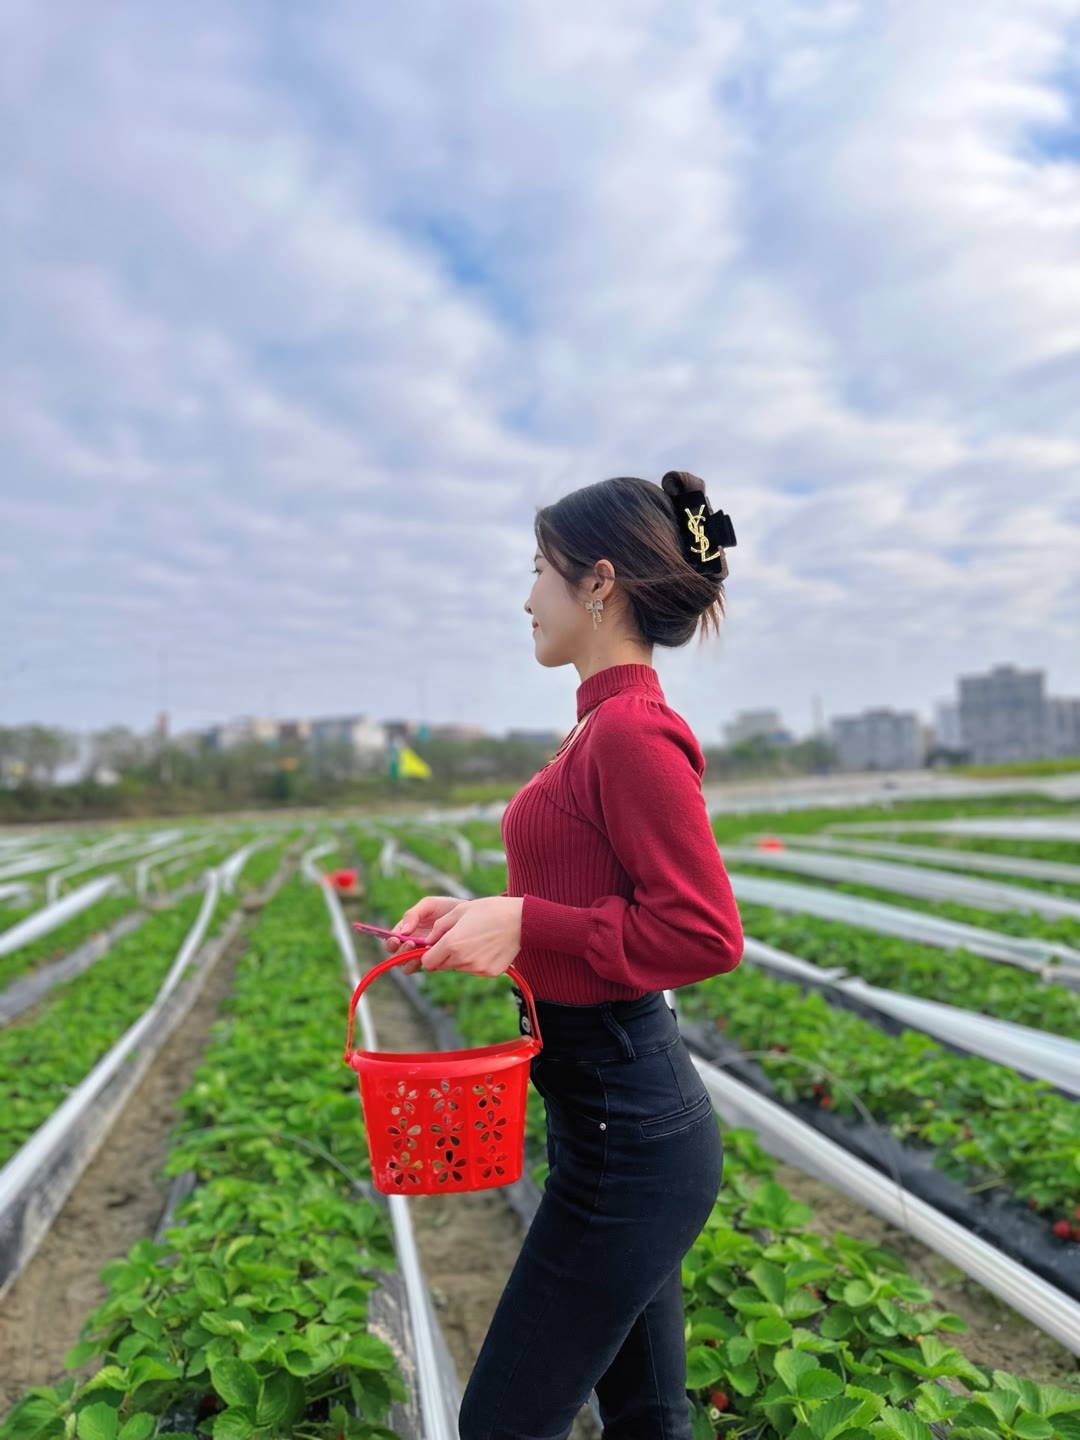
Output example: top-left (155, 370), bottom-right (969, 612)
top-left (958, 665), bottom-right (1050, 765)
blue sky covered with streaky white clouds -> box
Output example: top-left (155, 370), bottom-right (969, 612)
top-left (0, 0), bottom-right (1080, 744)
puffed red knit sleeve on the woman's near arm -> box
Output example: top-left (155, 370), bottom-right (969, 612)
top-left (521, 698), bottom-right (743, 989)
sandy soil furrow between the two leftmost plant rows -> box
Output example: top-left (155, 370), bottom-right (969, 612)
top-left (0, 929), bottom-right (246, 1416)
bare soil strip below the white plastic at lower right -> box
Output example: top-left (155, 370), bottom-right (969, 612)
top-left (776, 1165), bottom-right (1080, 1385)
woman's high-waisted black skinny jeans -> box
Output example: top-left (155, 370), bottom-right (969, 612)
top-left (458, 986), bottom-right (723, 1440)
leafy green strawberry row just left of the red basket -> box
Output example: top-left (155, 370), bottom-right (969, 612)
top-left (0, 880), bottom-right (408, 1440)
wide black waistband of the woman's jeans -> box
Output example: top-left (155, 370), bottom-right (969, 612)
top-left (513, 985), bottom-right (678, 1061)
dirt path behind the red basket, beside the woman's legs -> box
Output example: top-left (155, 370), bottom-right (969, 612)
top-left (357, 943), bottom-right (599, 1440)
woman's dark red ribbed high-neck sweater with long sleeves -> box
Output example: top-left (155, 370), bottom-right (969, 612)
top-left (503, 664), bottom-right (743, 1005)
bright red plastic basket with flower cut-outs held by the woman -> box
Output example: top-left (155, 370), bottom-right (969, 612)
top-left (344, 946), bottom-right (543, 1195)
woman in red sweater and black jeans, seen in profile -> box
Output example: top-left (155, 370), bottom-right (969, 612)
top-left (386, 471), bottom-right (743, 1440)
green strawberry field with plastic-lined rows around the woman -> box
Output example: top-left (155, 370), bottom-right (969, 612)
top-left (0, 801), bottom-right (1080, 1440)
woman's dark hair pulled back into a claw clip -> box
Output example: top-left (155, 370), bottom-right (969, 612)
top-left (534, 475), bottom-right (726, 649)
